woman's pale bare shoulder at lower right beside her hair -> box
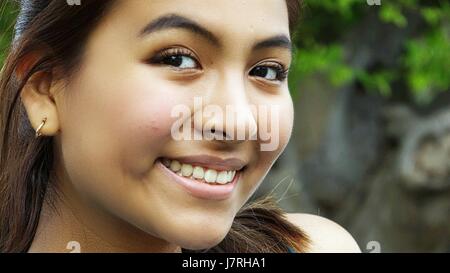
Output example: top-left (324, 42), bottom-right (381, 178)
top-left (286, 213), bottom-right (361, 252)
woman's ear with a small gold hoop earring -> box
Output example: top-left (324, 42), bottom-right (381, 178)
top-left (18, 55), bottom-right (59, 136)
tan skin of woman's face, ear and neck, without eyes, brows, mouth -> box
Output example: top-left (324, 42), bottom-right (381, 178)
top-left (21, 0), bottom-right (359, 252)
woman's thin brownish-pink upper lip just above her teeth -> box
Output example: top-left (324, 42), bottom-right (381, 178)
top-left (169, 155), bottom-right (246, 171)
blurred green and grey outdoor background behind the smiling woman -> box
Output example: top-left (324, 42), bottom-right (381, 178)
top-left (0, 0), bottom-right (450, 252)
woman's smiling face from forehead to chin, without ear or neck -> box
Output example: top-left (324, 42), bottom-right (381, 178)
top-left (52, 0), bottom-right (293, 249)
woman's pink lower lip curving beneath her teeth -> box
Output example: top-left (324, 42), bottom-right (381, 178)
top-left (156, 160), bottom-right (241, 200)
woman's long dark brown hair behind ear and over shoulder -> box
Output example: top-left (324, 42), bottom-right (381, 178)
top-left (0, 0), bottom-right (308, 252)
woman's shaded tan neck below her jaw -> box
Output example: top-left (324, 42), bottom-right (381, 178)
top-left (29, 177), bottom-right (181, 253)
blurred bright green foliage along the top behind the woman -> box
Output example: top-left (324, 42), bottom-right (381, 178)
top-left (0, 0), bottom-right (450, 104)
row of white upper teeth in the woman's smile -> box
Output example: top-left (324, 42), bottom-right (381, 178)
top-left (161, 158), bottom-right (236, 184)
